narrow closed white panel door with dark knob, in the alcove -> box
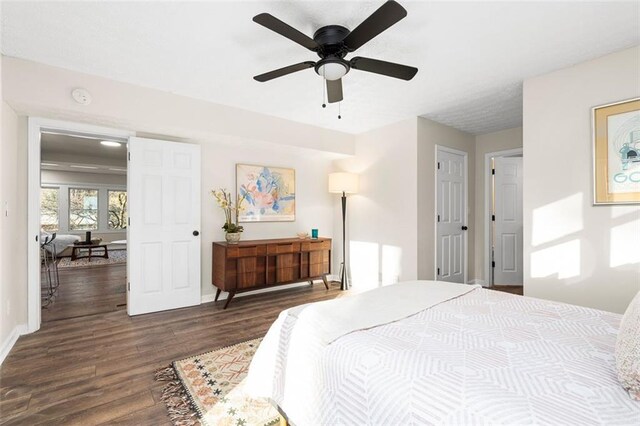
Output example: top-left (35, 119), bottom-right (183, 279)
top-left (436, 148), bottom-right (467, 283)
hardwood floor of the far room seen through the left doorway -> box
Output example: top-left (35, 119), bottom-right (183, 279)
top-left (40, 263), bottom-right (127, 322)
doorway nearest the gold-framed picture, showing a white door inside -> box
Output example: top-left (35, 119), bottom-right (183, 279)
top-left (485, 149), bottom-right (523, 294)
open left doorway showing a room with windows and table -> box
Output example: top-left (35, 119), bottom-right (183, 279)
top-left (40, 129), bottom-right (127, 322)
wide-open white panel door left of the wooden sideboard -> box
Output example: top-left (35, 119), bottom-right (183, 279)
top-left (127, 137), bottom-right (200, 315)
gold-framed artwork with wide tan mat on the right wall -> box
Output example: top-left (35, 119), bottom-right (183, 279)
top-left (593, 98), bottom-right (640, 204)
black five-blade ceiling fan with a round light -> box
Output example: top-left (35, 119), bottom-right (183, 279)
top-left (253, 0), bottom-right (418, 106)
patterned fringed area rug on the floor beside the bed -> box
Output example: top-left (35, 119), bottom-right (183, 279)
top-left (156, 339), bottom-right (280, 426)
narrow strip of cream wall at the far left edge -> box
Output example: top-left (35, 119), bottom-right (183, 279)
top-left (0, 102), bottom-right (27, 362)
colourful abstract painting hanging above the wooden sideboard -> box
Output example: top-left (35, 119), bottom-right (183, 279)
top-left (236, 164), bottom-right (296, 222)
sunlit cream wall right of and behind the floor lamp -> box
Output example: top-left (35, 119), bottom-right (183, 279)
top-left (336, 118), bottom-right (418, 290)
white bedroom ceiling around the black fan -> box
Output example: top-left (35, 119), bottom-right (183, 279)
top-left (2, 0), bottom-right (640, 134)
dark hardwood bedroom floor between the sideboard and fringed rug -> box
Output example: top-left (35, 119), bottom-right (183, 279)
top-left (0, 267), bottom-right (343, 425)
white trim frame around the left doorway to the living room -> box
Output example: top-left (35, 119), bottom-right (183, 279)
top-left (26, 117), bottom-right (135, 333)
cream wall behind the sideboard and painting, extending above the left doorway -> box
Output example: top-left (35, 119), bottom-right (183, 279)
top-left (2, 57), bottom-right (355, 310)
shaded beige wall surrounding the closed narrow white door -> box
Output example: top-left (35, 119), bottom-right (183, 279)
top-left (414, 117), bottom-right (475, 281)
